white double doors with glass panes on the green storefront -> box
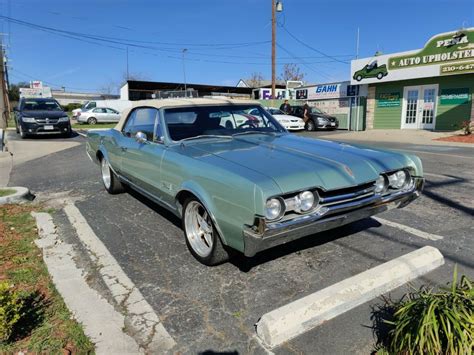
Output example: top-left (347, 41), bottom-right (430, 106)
top-left (402, 85), bottom-right (438, 129)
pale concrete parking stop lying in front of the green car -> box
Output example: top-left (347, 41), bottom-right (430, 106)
top-left (256, 246), bottom-right (444, 348)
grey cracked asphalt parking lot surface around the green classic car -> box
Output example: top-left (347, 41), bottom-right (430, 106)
top-left (4, 132), bottom-right (474, 354)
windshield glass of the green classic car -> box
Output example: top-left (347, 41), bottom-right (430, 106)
top-left (164, 105), bottom-right (286, 141)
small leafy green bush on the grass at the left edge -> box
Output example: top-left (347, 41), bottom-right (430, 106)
top-left (0, 282), bottom-right (23, 342)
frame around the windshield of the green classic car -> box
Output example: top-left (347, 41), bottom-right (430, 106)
top-left (159, 103), bottom-right (288, 145)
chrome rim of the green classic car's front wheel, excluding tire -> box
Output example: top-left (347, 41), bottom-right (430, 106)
top-left (184, 201), bottom-right (214, 258)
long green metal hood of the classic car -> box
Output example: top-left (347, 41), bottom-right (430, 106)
top-left (189, 134), bottom-right (417, 193)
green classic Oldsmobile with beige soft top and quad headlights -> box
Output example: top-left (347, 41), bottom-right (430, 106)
top-left (86, 99), bottom-right (424, 265)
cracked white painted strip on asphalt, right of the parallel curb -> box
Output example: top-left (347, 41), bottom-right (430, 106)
top-left (64, 203), bottom-right (176, 353)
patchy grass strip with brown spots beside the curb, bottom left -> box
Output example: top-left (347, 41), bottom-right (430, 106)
top-left (0, 205), bottom-right (94, 354)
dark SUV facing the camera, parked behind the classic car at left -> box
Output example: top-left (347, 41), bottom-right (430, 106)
top-left (14, 97), bottom-right (72, 138)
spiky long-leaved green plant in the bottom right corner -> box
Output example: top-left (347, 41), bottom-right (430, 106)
top-left (377, 269), bottom-right (474, 354)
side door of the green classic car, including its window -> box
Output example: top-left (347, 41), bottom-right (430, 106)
top-left (121, 107), bottom-right (165, 199)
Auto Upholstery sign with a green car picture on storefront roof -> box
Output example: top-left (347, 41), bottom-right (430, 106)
top-left (351, 28), bottom-right (474, 84)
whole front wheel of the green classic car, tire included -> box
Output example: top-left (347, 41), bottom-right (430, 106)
top-left (182, 198), bottom-right (229, 266)
